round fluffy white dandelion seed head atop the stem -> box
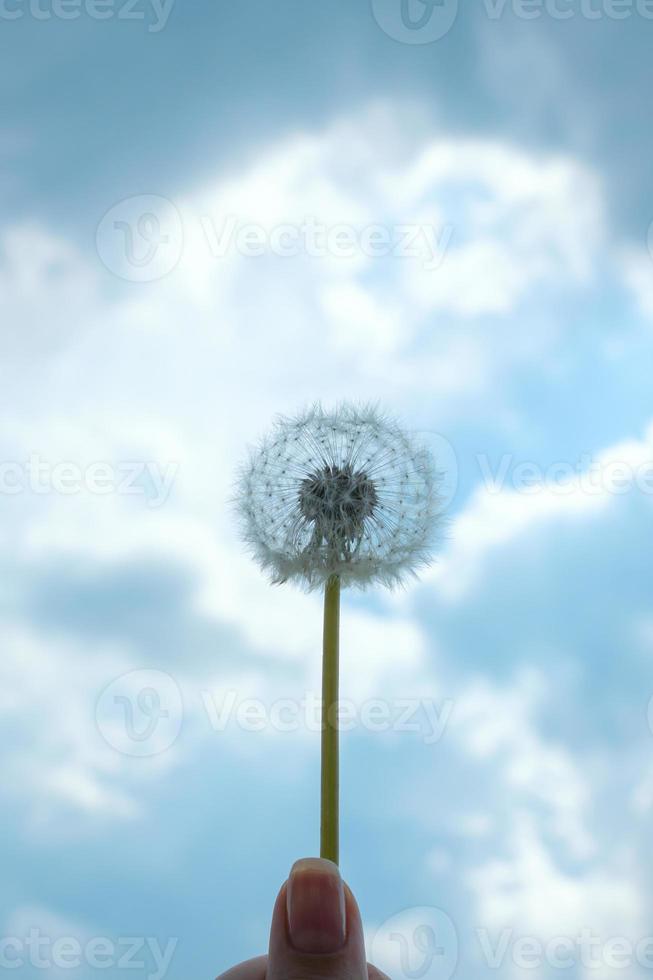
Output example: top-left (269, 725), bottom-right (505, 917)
top-left (237, 404), bottom-right (438, 589)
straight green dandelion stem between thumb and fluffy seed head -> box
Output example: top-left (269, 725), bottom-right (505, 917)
top-left (320, 575), bottom-right (340, 864)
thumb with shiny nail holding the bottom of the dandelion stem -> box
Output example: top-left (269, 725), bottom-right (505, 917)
top-left (266, 858), bottom-right (368, 980)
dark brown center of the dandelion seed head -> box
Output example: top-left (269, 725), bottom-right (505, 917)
top-left (299, 465), bottom-right (378, 553)
